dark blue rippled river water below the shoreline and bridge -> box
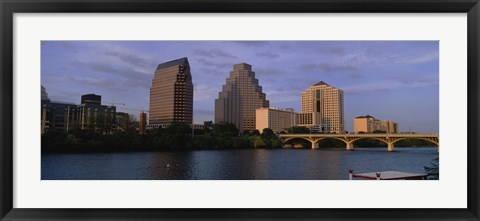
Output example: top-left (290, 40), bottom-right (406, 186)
top-left (42, 147), bottom-right (438, 180)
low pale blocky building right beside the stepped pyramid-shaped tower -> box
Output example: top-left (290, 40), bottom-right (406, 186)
top-left (255, 107), bottom-right (297, 133)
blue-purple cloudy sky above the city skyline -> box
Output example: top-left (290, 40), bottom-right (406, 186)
top-left (41, 41), bottom-right (439, 132)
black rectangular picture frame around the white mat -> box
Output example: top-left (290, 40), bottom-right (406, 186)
top-left (0, 0), bottom-right (480, 220)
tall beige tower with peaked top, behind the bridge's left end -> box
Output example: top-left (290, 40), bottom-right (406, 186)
top-left (302, 81), bottom-right (345, 133)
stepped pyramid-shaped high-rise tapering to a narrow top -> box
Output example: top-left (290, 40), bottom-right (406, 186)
top-left (215, 63), bottom-right (269, 131)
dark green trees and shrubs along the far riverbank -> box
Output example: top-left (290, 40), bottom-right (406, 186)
top-left (41, 120), bottom-right (433, 153)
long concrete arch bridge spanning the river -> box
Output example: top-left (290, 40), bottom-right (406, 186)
top-left (279, 134), bottom-right (439, 151)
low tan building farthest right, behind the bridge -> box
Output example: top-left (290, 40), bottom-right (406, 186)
top-left (353, 115), bottom-right (398, 133)
